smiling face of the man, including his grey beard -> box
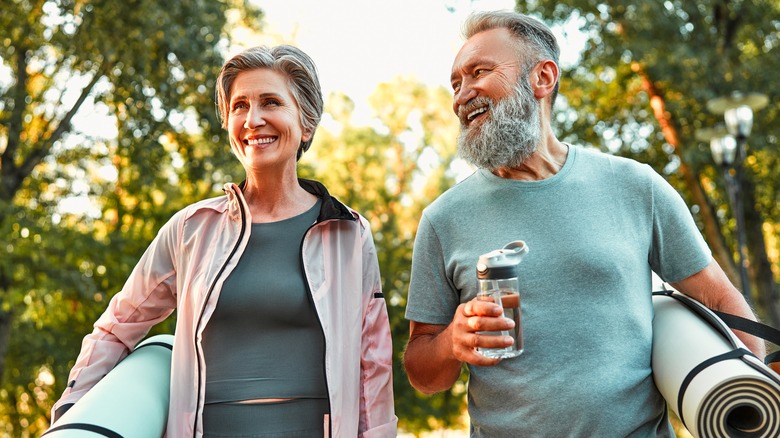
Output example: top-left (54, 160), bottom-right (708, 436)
top-left (452, 29), bottom-right (541, 170)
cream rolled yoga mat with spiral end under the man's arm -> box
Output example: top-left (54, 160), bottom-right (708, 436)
top-left (652, 292), bottom-right (780, 438)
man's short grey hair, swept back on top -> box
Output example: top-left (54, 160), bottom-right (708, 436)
top-left (463, 11), bottom-right (561, 103)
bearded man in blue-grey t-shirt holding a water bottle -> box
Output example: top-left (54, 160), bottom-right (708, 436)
top-left (404, 12), bottom-right (764, 437)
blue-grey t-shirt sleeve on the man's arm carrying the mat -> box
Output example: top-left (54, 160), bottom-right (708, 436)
top-left (650, 171), bottom-right (712, 283)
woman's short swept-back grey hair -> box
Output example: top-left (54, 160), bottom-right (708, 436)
top-left (216, 45), bottom-right (324, 159)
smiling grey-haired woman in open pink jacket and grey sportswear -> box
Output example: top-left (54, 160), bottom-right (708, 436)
top-left (53, 46), bottom-right (397, 437)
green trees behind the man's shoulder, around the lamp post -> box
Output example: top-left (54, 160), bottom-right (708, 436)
top-left (517, 0), bottom-right (780, 326)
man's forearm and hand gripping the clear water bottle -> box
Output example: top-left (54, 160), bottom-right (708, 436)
top-left (404, 300), bottom-right (514, 394)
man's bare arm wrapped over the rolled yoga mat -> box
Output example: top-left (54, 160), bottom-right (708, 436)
top-left (672, 260), bottom-right (766, 360)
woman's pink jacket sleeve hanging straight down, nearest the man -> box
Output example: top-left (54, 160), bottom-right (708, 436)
top-left (358, 217), bottom-right (398, 438)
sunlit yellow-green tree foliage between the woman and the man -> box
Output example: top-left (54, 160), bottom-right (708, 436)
top-left (302, 78), bottom-right (465, 432)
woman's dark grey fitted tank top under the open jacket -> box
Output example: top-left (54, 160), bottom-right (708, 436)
top-left (203, 201), bottom-right (327, 403)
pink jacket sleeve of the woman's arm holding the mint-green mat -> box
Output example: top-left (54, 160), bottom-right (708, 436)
top-left (51, 212), bottom-right (183, 421)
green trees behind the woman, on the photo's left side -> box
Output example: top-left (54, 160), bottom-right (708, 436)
top-left (0, 0), bottom-right (261, 436)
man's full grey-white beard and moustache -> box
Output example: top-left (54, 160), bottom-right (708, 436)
top-left (458, 74), bottom-right (542, 170)
